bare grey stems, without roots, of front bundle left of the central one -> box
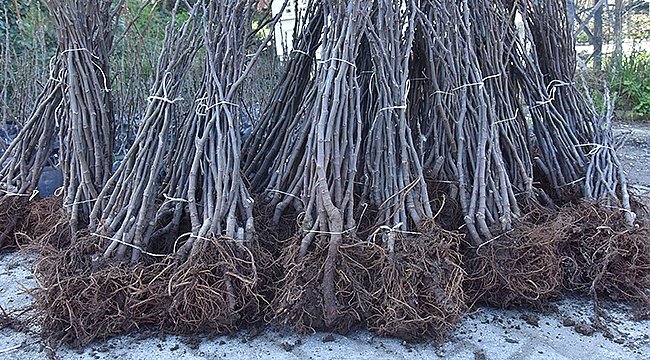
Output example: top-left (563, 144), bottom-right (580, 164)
top-left (159, 0), bottom-right (279, 258)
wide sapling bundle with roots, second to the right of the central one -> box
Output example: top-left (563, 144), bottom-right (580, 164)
top-left (409, 1), bottom-right (561, 305)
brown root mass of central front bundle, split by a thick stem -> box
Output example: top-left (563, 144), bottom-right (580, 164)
top-left (271, 237), bottom-right (383, 333)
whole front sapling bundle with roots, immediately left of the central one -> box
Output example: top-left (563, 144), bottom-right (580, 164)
top-left (148, 0), bottom-right (279, 332)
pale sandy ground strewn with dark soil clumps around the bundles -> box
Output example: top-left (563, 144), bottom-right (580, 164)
top-left (0, 122), bottom-right (650, 360)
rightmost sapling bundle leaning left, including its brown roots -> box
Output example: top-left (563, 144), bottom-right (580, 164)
top-left (522, 0), bottom-right (650, 316)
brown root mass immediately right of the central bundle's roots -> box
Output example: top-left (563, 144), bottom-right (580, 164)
top-left (368, 228), bottom-right (466, 341)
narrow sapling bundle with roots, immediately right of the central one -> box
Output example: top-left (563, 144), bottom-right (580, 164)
top-left (359, 0), bottom-right (465, 340)
